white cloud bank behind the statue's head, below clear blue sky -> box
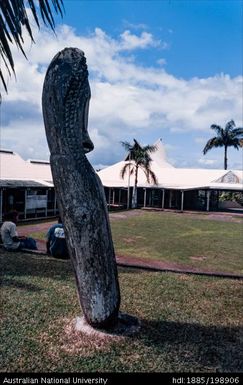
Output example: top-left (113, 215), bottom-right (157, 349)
top-left (1, 25), bottom-right (242, 170)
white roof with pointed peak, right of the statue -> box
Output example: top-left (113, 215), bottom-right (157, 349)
top-left (98, 140), bottom-right (243, 191)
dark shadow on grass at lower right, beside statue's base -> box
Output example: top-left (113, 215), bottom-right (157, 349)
top-left (140, 320), bottom-right (243, 372)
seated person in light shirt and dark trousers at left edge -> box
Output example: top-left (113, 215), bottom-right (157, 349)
top-left (1, 210), bottom-right (37, 251)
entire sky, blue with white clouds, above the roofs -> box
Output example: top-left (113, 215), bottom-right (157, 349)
top-left (1, 0), bottom-right (243, 169)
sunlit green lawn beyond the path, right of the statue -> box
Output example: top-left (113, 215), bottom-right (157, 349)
top-left (111, 212), bottom-right (243, 274)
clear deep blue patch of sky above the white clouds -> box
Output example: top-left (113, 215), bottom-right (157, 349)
top-left (58, 0), bottom-right (242, 78)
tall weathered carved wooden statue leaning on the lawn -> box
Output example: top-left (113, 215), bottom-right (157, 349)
top-left (42, 48), bottom-right (120, 328)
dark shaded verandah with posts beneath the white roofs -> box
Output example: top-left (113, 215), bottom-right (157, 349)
top-left (0, 186), bottom-right (243, 221)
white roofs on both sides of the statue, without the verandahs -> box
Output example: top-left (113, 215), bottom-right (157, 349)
top-left (0, 140), bottom-right (243, 191)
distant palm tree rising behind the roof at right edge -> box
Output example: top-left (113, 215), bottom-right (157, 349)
top-left (203, 120), bottom-right (243, 170)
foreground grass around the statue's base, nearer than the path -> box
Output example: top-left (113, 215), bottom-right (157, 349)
top-left (0, 250), bottom-right (243, 372)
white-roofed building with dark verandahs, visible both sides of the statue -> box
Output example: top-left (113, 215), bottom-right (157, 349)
top-left (0, 139), bottom-right (243, 220)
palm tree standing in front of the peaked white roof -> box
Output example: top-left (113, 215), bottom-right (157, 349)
top-left (121, 139), bottom-right (158, 208)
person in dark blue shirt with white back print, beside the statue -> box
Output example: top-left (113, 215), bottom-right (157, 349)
top-left (46, 217), bottom-right (69, 259)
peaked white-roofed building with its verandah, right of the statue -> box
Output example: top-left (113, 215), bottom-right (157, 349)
top-left (98, 139), bottom-right (243, 211)
